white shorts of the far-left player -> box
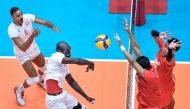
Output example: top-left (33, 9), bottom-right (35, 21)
top-left (15, 46), bottom-right (40, 64)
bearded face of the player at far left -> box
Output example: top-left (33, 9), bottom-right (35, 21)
top-left (12, 10), bottom-right (23, 26)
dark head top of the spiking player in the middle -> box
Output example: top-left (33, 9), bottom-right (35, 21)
top-left (56, 41), bottom-right (71, 54)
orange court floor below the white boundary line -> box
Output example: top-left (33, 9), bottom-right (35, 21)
top-left (0, 58), bottom-right (190, 109)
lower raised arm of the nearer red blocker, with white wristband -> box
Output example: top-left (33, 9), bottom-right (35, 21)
top-left (115, 33), bottom-right (144, 76)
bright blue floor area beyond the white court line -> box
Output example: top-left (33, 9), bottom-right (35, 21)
top-left (0, 0), bottom-right (190, 61)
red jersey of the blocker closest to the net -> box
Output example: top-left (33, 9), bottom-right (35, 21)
top-left (136, 67), bottom-right (161, 109)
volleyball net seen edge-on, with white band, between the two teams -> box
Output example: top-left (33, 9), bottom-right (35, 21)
top-left (125, 0), bottom-right (138, 109)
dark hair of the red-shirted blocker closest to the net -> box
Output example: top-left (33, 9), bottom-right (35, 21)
top-left (136, 56), bottom-right (151, 70)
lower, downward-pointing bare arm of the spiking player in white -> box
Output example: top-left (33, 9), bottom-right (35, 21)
top-left (65, 74), bottom-right (95, 104)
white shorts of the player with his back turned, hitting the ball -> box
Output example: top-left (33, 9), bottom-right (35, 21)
top-left (46, 91), bottom-right (78, 109)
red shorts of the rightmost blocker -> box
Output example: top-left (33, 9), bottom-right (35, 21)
top-left (161, 88), bottom-right (175, 107)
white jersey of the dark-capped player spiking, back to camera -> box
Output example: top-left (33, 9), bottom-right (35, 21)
top-left (45, 52), bottom-right (70, 89)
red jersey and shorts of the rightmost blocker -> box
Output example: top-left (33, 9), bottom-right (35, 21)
top-left (156, 39), bottom-right (175, 106)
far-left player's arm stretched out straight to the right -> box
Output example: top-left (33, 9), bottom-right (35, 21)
top-left (34, 17), bottom-right (60, 32)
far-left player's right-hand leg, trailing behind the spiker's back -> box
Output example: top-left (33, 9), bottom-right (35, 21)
top-left (32, 53), bottom-right (46, 89)
